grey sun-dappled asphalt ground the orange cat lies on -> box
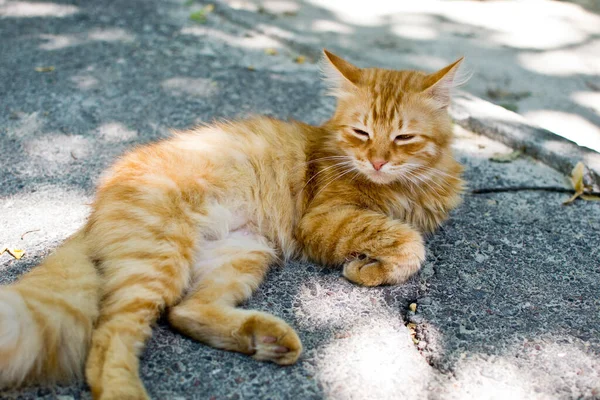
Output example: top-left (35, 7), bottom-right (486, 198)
top-left (0, 0), bottom-right (600, 400)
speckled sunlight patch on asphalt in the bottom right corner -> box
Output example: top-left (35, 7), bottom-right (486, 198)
top-left (445, 337), bottom-right (600, 400)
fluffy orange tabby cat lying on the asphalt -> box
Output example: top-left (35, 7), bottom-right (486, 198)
top-left (0, 50), bottom-right (463, 400)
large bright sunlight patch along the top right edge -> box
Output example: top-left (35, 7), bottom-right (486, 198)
top-left (309, 0), bottom-right (600, 50)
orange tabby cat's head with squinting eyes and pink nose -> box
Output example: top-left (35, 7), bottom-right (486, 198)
top-left (322, 50), bottom-right (463, 184)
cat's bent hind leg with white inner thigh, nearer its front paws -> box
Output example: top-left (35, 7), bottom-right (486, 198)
top-left (169, 231), bottom-right (302, 365)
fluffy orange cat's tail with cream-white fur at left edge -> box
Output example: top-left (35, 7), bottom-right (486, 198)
top-left (0, 231), bottom-right (100, 389)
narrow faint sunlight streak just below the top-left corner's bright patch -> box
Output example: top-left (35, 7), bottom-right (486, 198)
top-left (39, 28), bottom-right (135, 50)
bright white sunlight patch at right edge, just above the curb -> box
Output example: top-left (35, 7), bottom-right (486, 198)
top-left (524, 110), bottom-right (600, 151)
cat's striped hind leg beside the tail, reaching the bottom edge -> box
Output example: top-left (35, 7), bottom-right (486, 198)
top-left (86, 252), bottom-right (190, 400)
